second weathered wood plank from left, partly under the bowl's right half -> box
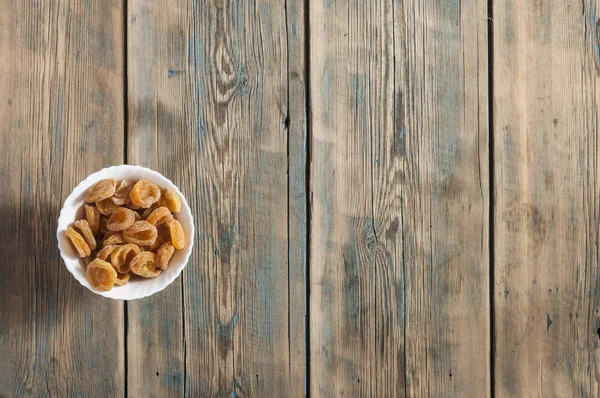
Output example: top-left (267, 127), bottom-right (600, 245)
top-left (128, 0), bottom-right (306, 397)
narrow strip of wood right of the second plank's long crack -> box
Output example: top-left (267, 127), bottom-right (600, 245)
top-left (284, 0), bottom-right (308, 396)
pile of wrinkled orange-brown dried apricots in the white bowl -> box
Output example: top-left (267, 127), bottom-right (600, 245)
top-left (66, 178), bottom-right (185, 291)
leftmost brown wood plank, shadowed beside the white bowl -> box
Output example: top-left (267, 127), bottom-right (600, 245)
top-left (0, 0), bottom-right (124, 397)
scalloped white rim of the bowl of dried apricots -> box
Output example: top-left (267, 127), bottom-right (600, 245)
top-left (56, 164), bottom-right (195, 301)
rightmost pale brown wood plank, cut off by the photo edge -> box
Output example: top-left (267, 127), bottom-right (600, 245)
top-left (493, 0), bottom-right (600, 397)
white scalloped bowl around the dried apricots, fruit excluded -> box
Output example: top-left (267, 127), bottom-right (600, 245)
top-left (56, 165), bottom-right (194, 300)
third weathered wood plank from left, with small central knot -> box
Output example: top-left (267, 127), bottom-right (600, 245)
top-left (310, 0), bottom-right (490, 396)
